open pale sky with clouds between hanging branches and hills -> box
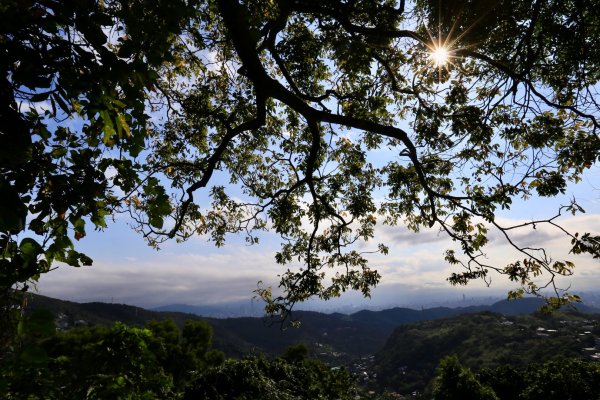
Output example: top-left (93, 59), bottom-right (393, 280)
top-left (38, 163), bottom-right (600, 308)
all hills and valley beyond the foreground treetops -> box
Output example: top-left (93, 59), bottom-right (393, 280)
top-left (17, 296), bottom-right (600, 398)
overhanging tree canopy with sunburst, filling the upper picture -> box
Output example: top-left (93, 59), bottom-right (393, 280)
top-left (0, 0), bottom-right (600, 313)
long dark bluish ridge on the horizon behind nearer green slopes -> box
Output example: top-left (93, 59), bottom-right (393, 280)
top-left (30, 295), bottom-right (598, 362)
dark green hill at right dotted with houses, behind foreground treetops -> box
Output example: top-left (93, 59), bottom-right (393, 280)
top-left (369, 312), bottom-right (600, 393)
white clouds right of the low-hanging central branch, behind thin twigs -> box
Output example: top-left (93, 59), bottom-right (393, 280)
top-left (372, 215), bottom-right (600, 291)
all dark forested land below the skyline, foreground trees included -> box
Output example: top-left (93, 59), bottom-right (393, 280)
top-left (0, 296), bottom-right (600, 400)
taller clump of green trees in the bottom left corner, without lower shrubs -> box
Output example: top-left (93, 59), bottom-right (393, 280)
top-left (0, 318), bottom-right (224, 399)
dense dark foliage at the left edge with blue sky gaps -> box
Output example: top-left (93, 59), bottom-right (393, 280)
top-left (0, 0), bottom-right (199, 326)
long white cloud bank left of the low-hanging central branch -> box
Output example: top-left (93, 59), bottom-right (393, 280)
top-left (38, 244), bottom-right (278, 307)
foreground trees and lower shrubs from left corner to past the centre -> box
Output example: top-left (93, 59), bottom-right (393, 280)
top-left (0, 318), bottom-right (358, 400)
